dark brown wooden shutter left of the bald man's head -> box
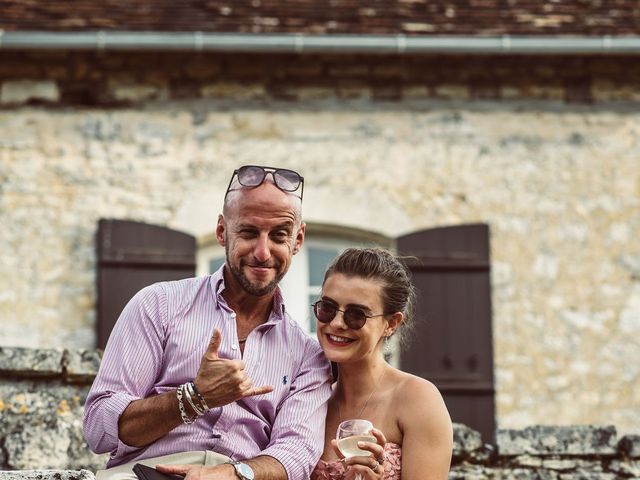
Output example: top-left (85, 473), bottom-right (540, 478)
top-left (96, 219), bottom-right (196, 348)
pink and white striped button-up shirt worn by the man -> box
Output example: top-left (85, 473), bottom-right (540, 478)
top-left (84, 267), bottom-right (330, 480)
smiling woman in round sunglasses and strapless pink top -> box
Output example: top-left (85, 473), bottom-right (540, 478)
top-left (311, 248), bottom-right (453, 480)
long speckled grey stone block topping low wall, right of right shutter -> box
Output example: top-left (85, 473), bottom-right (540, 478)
top-left (497, 425), bottom-right (616, 456)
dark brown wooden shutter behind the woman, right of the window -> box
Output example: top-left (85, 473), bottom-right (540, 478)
top-left (397, 224), bottom-right (495, 442)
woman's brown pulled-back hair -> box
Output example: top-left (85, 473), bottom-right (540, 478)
top-left (323, 248), bottom-right (416, 342)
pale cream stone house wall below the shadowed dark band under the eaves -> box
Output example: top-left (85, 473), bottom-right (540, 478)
top-left (0, 98), bottom-right (640, 431)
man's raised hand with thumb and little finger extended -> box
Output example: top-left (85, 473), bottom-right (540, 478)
top-left (194, 328), bottom-right (273, 408)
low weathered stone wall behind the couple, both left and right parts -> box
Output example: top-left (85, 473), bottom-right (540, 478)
top-left (0, 348), bottom-right (640, 480)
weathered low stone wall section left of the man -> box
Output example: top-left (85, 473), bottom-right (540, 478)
top-left (0, 348), bottom-right (107, 470)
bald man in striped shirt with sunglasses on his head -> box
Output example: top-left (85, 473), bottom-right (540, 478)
top-left (84, 166), bottom-right (330, 480)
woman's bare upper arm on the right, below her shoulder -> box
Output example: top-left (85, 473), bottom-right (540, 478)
top-left (394, 376), bottom-right (453, 480)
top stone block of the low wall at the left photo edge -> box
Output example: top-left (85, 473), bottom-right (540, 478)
top-left (0, 347), bottom-right (63, 378)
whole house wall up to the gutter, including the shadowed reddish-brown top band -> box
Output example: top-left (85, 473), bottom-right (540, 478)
top-left (0, 52), bottom-right (640, 438)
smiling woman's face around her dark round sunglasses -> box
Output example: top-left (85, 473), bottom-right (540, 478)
top-left (317, 273), bottom-right (388, 363)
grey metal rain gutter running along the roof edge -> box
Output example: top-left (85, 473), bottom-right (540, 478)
top-left (0, 30), bottom-right (640, 55)
